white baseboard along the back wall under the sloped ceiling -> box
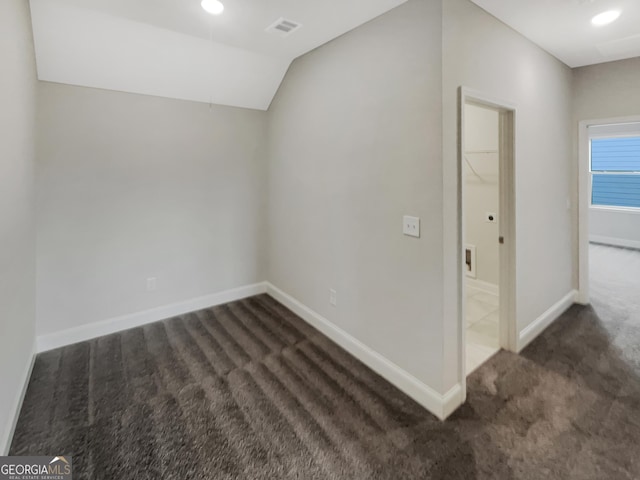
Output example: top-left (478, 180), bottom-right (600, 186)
top-left (36, 282), bottom-right (267, 353)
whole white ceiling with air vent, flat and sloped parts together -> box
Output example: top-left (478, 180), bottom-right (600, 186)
top-left (30, 0), bottom-right (406, 110)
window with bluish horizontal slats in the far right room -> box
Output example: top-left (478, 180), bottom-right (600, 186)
top-left (591, 136), bottom-right (640, 208)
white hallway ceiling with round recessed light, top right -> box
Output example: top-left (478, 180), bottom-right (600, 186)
top-left (472, 0), bottom-right (640, 67)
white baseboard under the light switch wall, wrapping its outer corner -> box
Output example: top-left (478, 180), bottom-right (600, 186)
top-left (267, 282), bottom-right (462, 420)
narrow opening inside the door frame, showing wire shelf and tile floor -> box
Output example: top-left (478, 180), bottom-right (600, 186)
top-left (462, 103), bottom-right (501, 375)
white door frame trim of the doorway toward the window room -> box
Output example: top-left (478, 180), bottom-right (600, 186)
top-left (576, 115), bottom-right (640, 305)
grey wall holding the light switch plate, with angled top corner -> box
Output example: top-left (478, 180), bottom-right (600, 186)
top-left (268, 0), bottom-right (444, 393)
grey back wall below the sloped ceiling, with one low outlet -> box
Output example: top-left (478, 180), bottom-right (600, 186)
top-left (37, 83), bottom-right (266, 335)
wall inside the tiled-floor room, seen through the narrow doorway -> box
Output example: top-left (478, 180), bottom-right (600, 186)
top-left (462, 104), bottom-right (500, 289)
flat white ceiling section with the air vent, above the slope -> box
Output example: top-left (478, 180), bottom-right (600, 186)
top-left (56, 0), bottom-right (406, 60)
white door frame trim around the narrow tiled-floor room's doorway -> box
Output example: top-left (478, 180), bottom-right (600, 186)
top-left (456, 87), bottom-right (518, 401)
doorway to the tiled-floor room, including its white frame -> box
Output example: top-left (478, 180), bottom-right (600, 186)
top-left (458, 88), bottom-right (517, 390)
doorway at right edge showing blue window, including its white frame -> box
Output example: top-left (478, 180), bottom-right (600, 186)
top-left (578, 116), bottom-right (640, 304)
